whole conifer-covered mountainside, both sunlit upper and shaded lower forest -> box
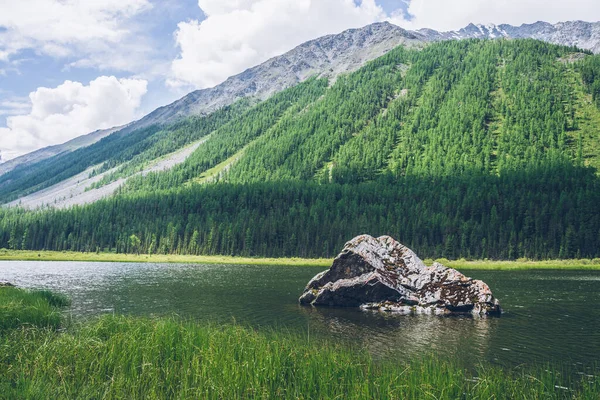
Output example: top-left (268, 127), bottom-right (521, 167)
top-left (0, 40), bottom-right (600, 258)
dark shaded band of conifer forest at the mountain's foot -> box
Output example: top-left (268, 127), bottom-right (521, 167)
top-left (0, 164), bottom-right (600, 259)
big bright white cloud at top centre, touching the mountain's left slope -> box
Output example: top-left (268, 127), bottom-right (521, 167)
top-left (169, 0), bottom-right (386, 88)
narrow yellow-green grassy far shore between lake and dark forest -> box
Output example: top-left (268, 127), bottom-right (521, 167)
top-left (0, 249), bottom-right (600, 271)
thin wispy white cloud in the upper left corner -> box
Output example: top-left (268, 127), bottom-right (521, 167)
top-left (0, 0), bottom-right (150, 68)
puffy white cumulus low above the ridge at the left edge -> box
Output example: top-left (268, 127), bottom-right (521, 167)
top-left (0, 76), bottom-right (147, 161)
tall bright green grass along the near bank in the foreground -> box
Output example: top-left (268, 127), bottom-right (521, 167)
top-left (0, 288), bottom-right (600, 399)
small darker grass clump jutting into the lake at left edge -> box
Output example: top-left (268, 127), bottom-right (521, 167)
top-left (0, 287), bottom-right (69, 334)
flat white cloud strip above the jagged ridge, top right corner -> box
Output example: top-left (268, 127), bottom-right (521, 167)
top-left (392, 0), bottom-right (600, 31)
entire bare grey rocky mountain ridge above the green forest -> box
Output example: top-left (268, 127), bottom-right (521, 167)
top-left (0, 21), bottom-right (600, 175)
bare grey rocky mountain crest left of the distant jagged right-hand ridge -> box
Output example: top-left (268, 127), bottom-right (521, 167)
top-left (0, 23), bottom-right (423, 175)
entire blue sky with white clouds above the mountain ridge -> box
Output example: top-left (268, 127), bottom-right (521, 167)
top-left (0, 0), bottom-right (600, 162)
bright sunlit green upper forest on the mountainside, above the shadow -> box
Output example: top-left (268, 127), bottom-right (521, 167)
top-left (126, 40), bottom-right (600, 190)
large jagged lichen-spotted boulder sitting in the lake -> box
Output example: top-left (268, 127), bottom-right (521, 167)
top-left (300, 235), bottom-right (501, 315)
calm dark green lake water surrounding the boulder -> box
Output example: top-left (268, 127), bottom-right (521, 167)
top-left (0, 261), bottom-right (600, 371)
